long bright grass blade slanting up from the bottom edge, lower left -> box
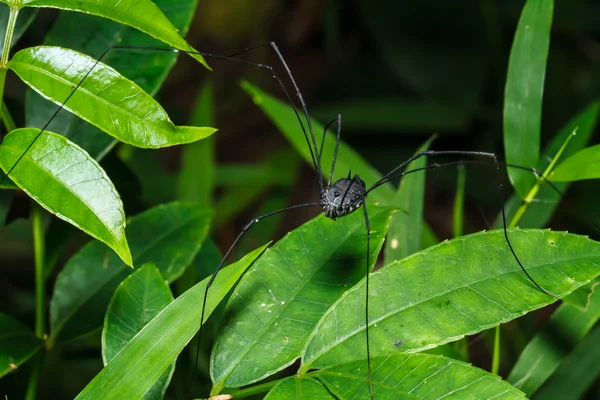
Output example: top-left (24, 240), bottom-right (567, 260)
top-left (77, 245), bottom-right (267, 400)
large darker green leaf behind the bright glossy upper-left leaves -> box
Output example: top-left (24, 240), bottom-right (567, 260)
top-left (26, 0), bottom-right (199, 160)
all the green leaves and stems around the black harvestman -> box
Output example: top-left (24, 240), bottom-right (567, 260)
top-left (0, 0), bottom-right (600, 399)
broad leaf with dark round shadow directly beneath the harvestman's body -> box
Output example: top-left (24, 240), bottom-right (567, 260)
top-left (211, 206), bottom-right (392, 393)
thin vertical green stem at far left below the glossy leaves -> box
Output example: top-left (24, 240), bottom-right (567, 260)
top-left (26, 204), bottom-right (46, 400)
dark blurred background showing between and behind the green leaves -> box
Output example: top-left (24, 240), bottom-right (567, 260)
top-left (0, 0), bottom-right (600, 398)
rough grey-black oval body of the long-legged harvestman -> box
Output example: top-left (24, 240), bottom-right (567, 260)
top-left (321, 175), bottom-right (367, 220)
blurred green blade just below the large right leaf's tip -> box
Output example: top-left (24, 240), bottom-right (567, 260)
top-left (507, 280), bottom-right (600, 396)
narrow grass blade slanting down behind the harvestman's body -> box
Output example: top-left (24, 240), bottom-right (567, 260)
top-left (242, 82), bottom-right (394, 205)
